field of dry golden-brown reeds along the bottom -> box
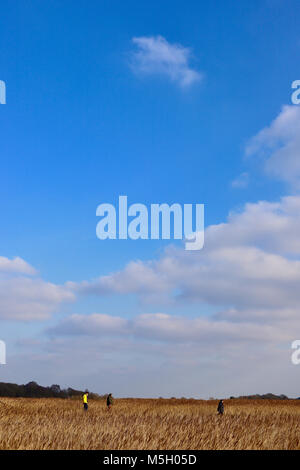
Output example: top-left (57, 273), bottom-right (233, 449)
top-left (0, 398), bottom-right (300, 450)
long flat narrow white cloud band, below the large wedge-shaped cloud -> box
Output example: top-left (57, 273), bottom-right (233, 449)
top-left (48, 311), bottom-right (291, 345)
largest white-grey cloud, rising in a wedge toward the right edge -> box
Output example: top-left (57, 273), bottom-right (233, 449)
top-left (69, 196), bottom-right (300, 316)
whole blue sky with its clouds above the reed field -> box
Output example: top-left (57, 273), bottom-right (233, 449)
top-left (0, 0), bottom-right (300, 397)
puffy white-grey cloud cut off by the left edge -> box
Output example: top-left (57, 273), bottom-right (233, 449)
top-left (0, 257), bottom-right (75, 321)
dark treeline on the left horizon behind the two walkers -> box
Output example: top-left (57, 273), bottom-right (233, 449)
top-left (0, 382), bottom-right (107, 400)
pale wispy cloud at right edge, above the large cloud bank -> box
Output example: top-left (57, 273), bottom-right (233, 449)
top-left (246, 105), bottom-right (300, 190)
